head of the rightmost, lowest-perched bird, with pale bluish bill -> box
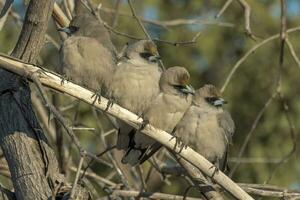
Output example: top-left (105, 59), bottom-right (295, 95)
top-left (194, 84), bottom-right (227, 107)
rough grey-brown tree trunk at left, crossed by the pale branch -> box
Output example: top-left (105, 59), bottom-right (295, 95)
top-left (0, 0), bottom-right (59, 199)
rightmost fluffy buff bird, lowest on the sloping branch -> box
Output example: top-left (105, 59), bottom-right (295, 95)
top-left (174, 85), bottom-right (235, 171)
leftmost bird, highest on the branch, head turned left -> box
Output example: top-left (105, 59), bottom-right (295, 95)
top-left (60, 13), bottom-right (117, 97)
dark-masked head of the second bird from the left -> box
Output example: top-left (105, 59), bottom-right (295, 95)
top-left (125, 40), bottom-right (160, 63)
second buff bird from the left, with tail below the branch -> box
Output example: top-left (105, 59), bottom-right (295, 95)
top-left (108, 40), bottom-right (161, 150)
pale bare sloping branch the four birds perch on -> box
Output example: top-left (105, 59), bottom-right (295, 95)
top-left (0, 55), bottom-right (253, 200)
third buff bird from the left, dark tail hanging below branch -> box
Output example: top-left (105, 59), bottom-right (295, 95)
top-left (122, 66), bottom-right (194, 165)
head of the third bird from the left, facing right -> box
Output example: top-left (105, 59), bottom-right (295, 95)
top-left (159, 66), bottom-right (195, 96)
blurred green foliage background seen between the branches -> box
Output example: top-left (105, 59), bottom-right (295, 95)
top-left (0, 0), bottom-right (300, 198)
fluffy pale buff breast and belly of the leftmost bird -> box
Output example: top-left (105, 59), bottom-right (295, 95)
top-left (61, 36), bottom-right (115, 90)
